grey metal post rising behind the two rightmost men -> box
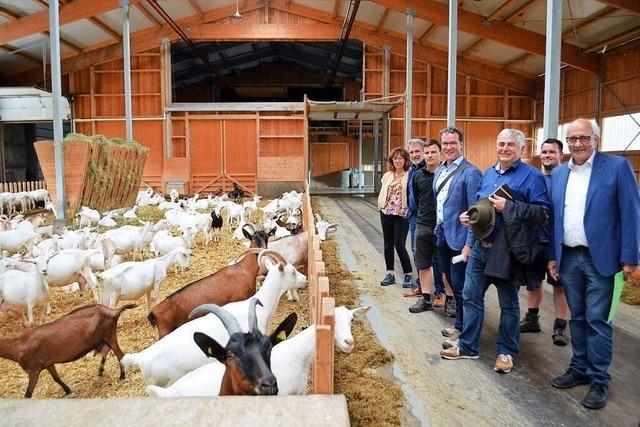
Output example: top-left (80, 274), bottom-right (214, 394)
top-left (542, 0), bottom-right (562, 139)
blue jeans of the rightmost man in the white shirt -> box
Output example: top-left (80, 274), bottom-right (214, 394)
top-left (560, 246), bottom-right (613, 386)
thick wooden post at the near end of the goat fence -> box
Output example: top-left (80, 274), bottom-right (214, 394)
top-left (313, 298), bottom-right (335, 394)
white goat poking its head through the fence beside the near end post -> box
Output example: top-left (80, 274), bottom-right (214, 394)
top-left (146, 306), bottom-right (371, 397)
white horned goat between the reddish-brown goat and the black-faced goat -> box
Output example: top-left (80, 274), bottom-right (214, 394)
top-left (122, 251), bottom-right (307, 386)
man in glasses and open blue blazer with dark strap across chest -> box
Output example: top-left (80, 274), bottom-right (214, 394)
top-left (433, 126), bottom-right (482, 341)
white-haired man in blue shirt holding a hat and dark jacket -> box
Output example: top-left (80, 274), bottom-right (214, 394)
top-left (440, 129), bottom-right (550, 373)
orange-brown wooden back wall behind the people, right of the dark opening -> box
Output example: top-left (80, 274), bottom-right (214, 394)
top-left (364, 46), bottom-right (535, 168)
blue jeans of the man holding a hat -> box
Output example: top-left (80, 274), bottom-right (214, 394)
top-left (458, 242), bottom-right (520, 357)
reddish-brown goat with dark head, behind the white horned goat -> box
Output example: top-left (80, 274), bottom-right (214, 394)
top-left (147, 232), bottom-right (268, 339)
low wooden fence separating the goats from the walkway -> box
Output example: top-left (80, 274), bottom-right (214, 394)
top-left (302, 183), bottom-right (335, 394)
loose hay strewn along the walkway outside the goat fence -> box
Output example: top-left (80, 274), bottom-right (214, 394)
top-left (312, 199), bottom-right (404, 426)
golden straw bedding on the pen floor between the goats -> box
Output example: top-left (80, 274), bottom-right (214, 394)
top-left (0, 207), bottom-right (309, 398)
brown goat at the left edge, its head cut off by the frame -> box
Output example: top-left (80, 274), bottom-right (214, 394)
top-left (0, 304), bottom-right (136, 398)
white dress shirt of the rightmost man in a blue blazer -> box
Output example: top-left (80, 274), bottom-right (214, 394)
top-left (563, 151), bottom-right (596, 248)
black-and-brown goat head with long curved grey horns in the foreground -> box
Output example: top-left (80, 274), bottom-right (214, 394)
top-left (191, 298), bottom-right (278, 396)
